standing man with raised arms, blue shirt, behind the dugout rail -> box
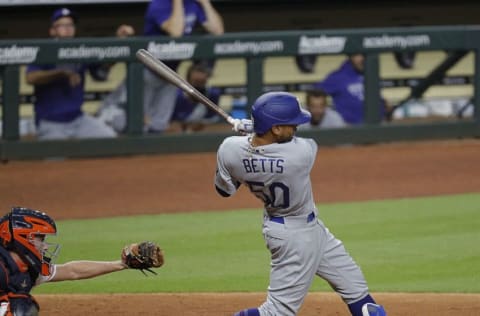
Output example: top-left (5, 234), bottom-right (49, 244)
top-left (143, 0), bottom-right (224, 133)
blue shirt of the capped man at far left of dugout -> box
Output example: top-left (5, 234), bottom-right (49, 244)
top-left (27, 64), bottom-right (104, 123)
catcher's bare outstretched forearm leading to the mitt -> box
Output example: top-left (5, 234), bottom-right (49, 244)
top-left (52, 260), bottom-right (127, 281)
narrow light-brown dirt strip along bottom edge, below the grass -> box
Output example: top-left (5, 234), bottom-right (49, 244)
top-left (38, 293), bottom-right (480, 316)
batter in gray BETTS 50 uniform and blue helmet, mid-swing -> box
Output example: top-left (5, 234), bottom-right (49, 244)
top-left (215, 92), bottom-right (386, 316)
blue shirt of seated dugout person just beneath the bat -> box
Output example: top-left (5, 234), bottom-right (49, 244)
top-left (172, 88), bottom-right (220, 122)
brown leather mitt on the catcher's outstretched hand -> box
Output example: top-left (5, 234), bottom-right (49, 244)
top-left (122, 241), bottom-right (164, 274)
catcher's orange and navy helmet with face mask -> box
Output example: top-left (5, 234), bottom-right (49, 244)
top-left (0, 207), bottom-right (59, 275)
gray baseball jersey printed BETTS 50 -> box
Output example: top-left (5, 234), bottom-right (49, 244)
top-left (216, 136), bottom-right (317, 216)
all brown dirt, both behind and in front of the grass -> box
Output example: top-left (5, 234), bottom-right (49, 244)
top-left (0, 140), bottom-right (480, 316)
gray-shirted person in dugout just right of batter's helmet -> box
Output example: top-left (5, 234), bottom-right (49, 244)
top-left (298, 89), bottom-right (347, 130)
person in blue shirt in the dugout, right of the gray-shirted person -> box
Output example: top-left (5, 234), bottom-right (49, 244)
top-left (314, 54), bottom-right (385, 125)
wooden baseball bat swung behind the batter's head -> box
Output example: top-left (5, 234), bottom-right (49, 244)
top-left (136, 49), bottom-right (235, 125)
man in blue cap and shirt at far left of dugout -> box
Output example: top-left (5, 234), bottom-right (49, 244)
top-left (26, 8), bottom-right (131, 140)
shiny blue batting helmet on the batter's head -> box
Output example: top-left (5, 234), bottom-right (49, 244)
top-left (252, 92), bottom-right (311, 135)
